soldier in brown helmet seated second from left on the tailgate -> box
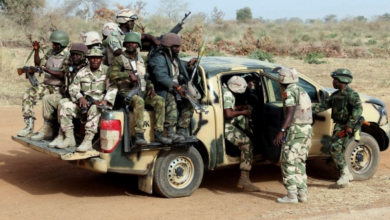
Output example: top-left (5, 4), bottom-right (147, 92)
top-left (31, 43), bottom-right (88, 143)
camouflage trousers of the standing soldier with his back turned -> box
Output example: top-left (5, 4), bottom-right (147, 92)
top-left (281, 131), bottom-right (311, 191)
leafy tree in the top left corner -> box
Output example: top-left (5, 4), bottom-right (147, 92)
top-left (0, 0), bottom-right (46, 25)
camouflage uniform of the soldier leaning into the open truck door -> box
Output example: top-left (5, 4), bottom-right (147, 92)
top-left (222, 85), bottom-right (253, 171)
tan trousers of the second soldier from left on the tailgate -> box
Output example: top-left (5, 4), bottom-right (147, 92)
top-left (42, 94), bottom-right (70, 120)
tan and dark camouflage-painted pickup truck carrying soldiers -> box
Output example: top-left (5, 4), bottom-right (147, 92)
top-left (12, 57), bottom-right (390, 197)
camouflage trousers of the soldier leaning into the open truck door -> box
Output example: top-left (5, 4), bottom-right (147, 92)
top-left (225, 115), bottom-right (253, 171)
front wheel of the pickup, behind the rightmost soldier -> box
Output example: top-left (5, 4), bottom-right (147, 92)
top-left (345, 132), bottom-right (380, 180)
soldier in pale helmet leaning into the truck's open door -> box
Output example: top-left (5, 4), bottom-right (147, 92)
top-left (222, 76), bottom-right (260, 192)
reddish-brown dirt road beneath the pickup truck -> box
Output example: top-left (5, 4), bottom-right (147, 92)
top-left (0, 105), bottom-right (390, 220)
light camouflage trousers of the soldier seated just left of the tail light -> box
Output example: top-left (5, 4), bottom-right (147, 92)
top-left (58, 102), bottom-right (101, 134)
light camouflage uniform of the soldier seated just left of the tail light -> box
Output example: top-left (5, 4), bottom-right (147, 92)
top-left (59, 65), bottom-right (116, 134)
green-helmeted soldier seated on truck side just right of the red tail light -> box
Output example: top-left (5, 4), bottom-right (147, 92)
top-left (109, 33), bottom-right (172, 145)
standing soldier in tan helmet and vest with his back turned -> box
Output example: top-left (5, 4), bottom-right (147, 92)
top-left (274, 67), bottom-right (313, 203)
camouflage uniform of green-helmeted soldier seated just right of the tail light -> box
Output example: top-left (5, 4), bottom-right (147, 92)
top-left (109, 51), bottom-right (165, 133)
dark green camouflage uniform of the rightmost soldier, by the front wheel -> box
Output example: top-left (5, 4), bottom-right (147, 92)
top-left (312, 86), bottom-right (363, 170)
